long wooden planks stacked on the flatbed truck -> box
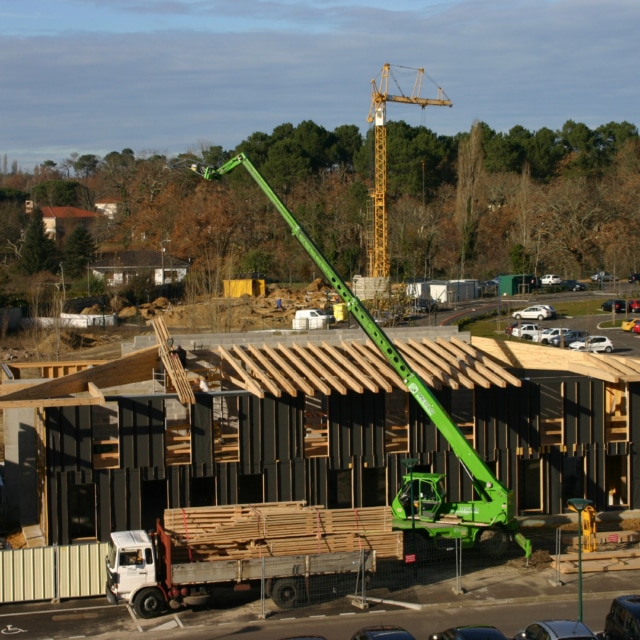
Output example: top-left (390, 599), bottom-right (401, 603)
top-left (164, 502), bottom-right (402, 562)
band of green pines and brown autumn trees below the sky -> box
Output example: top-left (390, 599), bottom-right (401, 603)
top-left (0, 120), bottom-right (640, 308)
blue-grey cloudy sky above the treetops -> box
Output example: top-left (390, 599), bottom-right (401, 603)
top-left (0, 0), bottom-right (640, 171)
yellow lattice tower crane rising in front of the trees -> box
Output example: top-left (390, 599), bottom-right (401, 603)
top-left (367, 62), bottom-right (453, 278)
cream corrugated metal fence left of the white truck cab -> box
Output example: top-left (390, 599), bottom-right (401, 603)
top-left (0, 542), bottom-right (108, 604)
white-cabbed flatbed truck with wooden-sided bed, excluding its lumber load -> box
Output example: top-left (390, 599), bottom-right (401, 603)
top-left (106, 522), bottom-right (376, 619)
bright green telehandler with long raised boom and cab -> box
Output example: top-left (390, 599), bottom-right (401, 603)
top-left (190, 153), bottom-right (531, 558)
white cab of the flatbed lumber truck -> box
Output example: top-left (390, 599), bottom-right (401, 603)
top-left (106, 531), bottom-right (157, 604)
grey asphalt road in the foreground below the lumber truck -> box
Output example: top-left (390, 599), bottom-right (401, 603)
top-left (0, 596), bottom-right (611, 640)
